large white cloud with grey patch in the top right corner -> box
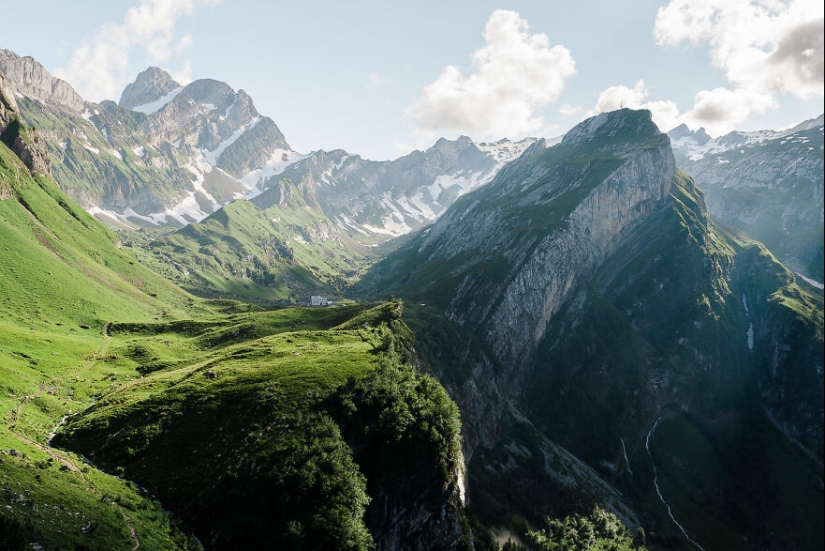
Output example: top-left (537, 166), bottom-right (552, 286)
top-left (653, 0), bottom-right (825, 134)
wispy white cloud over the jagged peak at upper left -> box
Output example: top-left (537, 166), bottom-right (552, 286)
top-left (55, 0), bottom-right (221, 101)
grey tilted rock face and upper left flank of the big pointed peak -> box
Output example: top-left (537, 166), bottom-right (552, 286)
top-left (400, 110), bottom-right (675, 455)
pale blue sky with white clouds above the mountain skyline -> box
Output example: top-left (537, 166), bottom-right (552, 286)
top-left (0, 0), bottom-right (825, 160)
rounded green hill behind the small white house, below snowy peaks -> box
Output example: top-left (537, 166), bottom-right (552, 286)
top-left (130, 180), bottom-right (368, 302)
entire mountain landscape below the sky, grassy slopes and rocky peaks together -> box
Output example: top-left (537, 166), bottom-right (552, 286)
top-left (0, 50), bottom-right (825, 549)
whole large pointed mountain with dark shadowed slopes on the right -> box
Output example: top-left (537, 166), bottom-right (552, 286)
top-left (358, 110), bottom-right (823, 549)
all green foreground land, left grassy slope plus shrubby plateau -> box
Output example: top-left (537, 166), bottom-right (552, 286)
top-left (0, 125), bottom-right (460, 549)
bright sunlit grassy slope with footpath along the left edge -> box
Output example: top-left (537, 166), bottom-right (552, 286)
top-left (0, 133), bottom-right (205, 549)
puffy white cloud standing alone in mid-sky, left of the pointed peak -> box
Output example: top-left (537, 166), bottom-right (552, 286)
top-left (406, 10), bottom-right (576, 138)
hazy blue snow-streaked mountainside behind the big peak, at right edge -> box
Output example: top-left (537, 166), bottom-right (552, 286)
top-left (669, 115), bottom-right (825, 282)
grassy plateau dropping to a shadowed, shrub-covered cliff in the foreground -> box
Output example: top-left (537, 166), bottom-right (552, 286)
top-left (55, 303), bottom-right (460, 549)
